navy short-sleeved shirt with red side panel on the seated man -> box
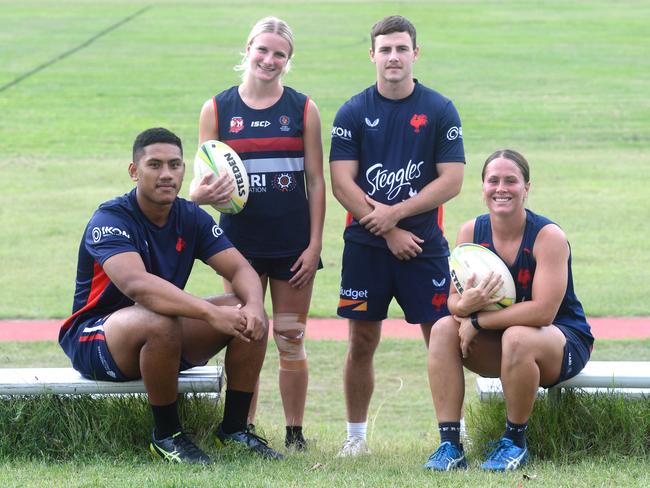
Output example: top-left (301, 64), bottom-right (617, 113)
top-left (59, 189), bottom-right (232, 344)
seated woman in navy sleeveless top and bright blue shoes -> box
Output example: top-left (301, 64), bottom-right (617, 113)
top-left (425, 149), bottom-right (594, 471)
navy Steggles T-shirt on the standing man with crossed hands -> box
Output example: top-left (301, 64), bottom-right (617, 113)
top-left (329, 80), bottom-right (465, 257)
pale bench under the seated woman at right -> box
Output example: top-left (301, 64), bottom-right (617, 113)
top-left (476, 361), bottom-right (650, 401)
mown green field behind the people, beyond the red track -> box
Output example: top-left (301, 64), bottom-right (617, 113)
top-left (0, 0), bottom-right (650, 318)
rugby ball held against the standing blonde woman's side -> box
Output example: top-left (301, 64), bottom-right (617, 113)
top-left (190, 140), bottom-right (248, 214)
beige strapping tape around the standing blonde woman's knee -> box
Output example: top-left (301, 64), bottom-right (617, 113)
top-left (273, 313), bottom-right (307, 371)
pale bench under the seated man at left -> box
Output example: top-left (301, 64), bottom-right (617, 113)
top-left (0, 366), bottom-right (223, 398)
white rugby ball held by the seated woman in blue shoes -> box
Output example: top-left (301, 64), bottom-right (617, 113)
top-left (449, 243), bottom-right (517, 310)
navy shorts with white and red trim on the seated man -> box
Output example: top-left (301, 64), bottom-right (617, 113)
top-left (64, 315), bottom-right (202, 381)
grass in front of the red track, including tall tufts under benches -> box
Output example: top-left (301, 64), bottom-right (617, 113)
top-left (0, 339), bottom-right (650, 487)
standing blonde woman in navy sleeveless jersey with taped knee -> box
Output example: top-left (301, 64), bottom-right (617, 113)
top-left (190, 17), bottom-right (325, 450)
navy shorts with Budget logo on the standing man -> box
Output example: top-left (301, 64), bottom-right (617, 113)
top-left (337, 242), bottom-right (450, 324)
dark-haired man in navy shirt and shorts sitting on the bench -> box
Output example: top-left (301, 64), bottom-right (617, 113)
top-left (59, 128), bottom-right (280, 464)
